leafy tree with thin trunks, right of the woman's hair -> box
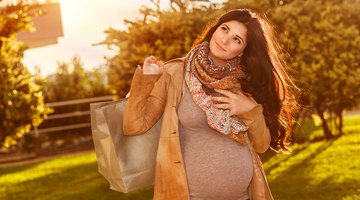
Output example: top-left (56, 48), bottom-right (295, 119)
top-left (274, 0), bottom-right (360, 139)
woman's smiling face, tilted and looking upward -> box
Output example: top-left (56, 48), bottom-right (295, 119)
top-left (210, 20), bottom-right (247, 63)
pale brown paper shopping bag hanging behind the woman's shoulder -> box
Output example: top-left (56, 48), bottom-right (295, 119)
top-left (90, 99), bottom-right (161, 193)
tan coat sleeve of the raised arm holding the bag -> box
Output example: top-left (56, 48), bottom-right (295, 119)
top-left (123, 68), bottom-right (167, 135)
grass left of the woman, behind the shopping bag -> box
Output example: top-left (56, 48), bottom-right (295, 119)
top-left (0, 153), bottom-right (153, 200)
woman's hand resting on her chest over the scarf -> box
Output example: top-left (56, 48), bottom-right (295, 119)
top-left (211, 89), bottom-right (257, 116)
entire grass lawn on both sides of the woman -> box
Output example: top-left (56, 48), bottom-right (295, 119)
top-left (0, 116), bottom-right (360, 200)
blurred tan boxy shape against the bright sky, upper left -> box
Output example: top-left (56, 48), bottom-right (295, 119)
top-left (17, 3), bottom-right (64, 48)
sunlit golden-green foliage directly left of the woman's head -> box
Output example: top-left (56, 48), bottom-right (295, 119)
top-left (102, 0), bottom-right (218, 97)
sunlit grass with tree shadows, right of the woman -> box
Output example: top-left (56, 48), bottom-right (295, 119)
top-left (263, 133), bottom-right (360, 200)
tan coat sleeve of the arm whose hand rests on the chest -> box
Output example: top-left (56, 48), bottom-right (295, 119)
top-left (238, 104), bottom-right (271, 153)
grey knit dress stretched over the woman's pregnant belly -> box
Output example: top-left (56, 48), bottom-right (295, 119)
top-left (177, 86), bottom-right (253, 200)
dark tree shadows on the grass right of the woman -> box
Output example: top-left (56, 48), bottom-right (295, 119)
top-left (266, 138), bottom-right (359, 200)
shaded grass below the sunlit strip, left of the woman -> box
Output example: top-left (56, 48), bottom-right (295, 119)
top-left (0, 159), bottom-right (153, 200)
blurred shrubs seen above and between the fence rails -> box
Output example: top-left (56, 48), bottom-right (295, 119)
top-left (34, 57), bottom-right (110, 152)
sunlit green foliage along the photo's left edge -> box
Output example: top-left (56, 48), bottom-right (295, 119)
top-left (0, 1), bottom-right (48, 148)
